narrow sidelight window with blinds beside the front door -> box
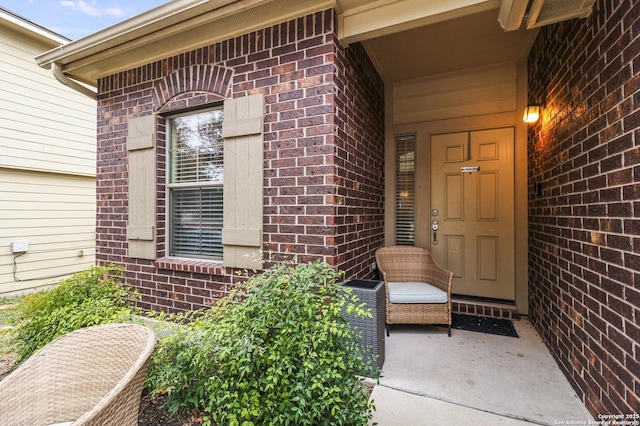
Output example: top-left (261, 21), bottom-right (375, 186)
top-left (395, 135), bottom-right (416, 245)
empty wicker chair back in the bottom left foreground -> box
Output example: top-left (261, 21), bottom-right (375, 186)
top-left (0, 324), bottom-right (156, 426)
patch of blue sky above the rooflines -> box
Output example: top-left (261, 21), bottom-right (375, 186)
top-left (0, 0), bottom-right (170, 40)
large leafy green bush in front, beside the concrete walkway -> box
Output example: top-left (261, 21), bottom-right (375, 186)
top-left (147, 262), bottom-right (373, 425)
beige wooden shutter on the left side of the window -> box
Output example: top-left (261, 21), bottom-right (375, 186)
top-left (127, 115), bottom-right (157, 259)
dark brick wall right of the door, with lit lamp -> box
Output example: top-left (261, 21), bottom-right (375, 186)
top-left (528, 0), bottom-right (640, 418)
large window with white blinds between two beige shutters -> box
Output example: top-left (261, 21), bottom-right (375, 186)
top-left (167, 107), bottom-right (224, 259)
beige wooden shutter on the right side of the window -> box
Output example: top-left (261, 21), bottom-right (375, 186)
top-left (222, 94), bottom-right (264, 269)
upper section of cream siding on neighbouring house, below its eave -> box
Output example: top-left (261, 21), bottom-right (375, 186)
top-left (0, 22), bottom-right (96, 176)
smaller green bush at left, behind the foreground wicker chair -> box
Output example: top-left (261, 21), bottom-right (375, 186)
top-left (10, 266), bottom-right (134, 361)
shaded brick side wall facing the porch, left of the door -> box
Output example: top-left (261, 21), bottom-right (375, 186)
top-left (333, 35), bottom-right (384, 278)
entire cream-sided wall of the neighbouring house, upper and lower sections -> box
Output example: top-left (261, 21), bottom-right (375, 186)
top-left (0, 11), bottom-right (96, 296)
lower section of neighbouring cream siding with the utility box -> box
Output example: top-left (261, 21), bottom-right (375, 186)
top-left (0, 168), bottom-right (96, 294)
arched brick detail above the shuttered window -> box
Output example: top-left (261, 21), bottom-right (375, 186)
top-left (153, 65), bottom-right (233, 112)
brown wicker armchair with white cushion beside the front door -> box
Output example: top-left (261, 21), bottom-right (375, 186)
top-left (376, 246), bottom-right (453, 337)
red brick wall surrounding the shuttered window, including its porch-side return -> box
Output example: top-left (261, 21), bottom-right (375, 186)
top-left (96, 10), bottom-right (384, 310)
